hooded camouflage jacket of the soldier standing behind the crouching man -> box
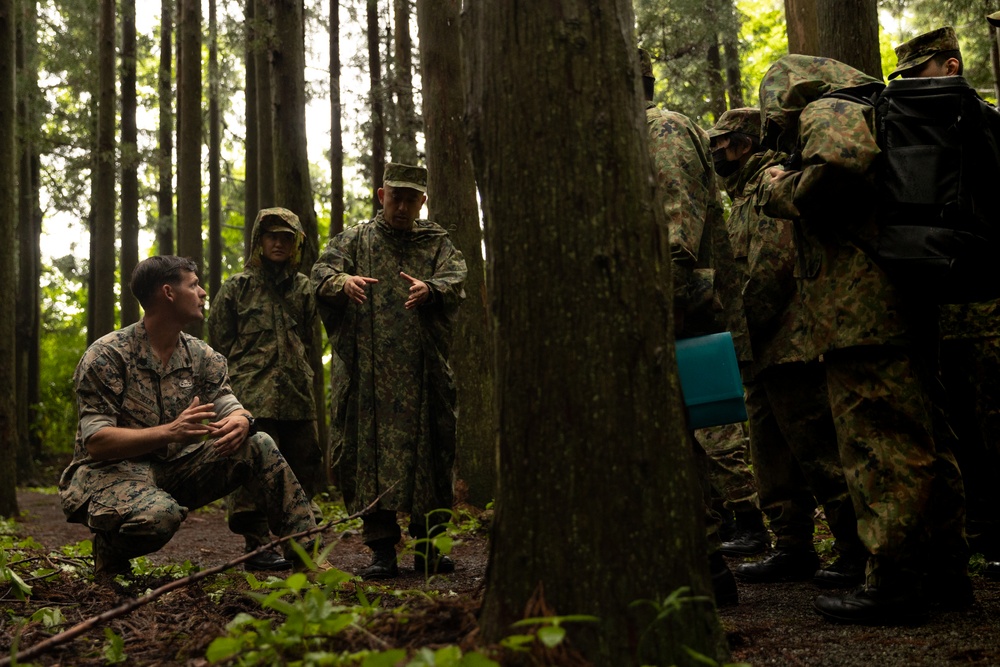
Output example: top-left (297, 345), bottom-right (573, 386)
top-left (208, 209), bottom-right (320, 420)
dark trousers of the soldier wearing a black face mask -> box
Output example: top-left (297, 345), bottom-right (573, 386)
top-left (747, 361), bottom-right (865, 559)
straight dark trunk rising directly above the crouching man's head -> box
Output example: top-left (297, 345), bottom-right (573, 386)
top-left (177, 0), bottom-right (205, 338)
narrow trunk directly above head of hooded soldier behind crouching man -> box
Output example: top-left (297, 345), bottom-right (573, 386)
top-left (249, 0), bottom-right (279, 206)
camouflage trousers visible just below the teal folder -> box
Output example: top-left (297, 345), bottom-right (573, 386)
top-left (695, 424), bottom-right (759, 513)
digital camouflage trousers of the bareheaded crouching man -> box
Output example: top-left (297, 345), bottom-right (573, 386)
top-left (85, 433), bottom-right (316, 563)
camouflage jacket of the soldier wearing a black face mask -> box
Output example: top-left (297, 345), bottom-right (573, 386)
top-left (726, 151), bottom-right (815, 372)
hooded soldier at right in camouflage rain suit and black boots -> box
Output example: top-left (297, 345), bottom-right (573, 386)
top-left (760, 55), bottom-right (971, 623)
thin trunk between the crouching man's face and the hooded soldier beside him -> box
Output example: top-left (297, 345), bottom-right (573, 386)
top-left (208, 0), bottom-right (222, 294)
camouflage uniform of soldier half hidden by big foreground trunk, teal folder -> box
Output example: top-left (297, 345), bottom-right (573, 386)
top-left (646, 103), bottom-right (750, 550)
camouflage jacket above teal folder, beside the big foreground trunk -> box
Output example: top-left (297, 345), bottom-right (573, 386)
top-left (646, 104), bottom-right (751, 361)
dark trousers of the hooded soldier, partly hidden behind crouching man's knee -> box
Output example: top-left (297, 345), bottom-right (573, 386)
top-left (226, 419), bottom-right (326, 551)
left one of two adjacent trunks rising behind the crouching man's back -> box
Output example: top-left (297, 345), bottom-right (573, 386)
top-left (90, 0), bottom-right (118, 340)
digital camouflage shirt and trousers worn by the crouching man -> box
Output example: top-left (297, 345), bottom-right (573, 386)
top-left (59, 321), bottom-right (316, 561)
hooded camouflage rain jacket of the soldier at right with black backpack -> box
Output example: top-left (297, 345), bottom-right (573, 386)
top-left (760, 55), bottom-right (911, 357)
